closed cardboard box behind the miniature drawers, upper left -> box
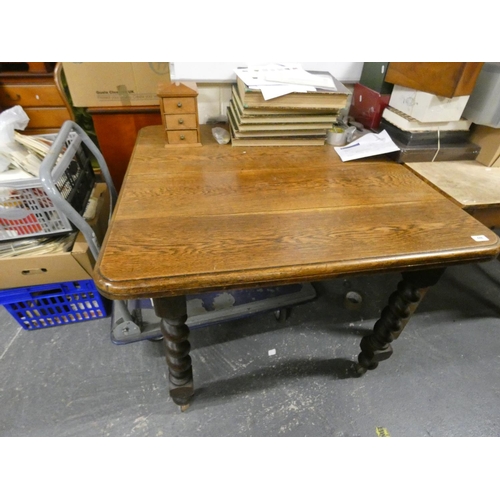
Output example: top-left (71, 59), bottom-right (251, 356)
top-left (63, 62), bottom-right (170, 108)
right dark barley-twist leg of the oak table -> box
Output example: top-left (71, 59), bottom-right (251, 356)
top-left (356, 269), bottom-right (444, 375)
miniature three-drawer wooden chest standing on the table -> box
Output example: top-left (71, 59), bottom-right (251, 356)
top-left (158, 82), bottom-right (201, 147)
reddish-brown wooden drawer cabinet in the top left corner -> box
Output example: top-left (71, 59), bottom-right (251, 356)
top-left (0, 63), bottom-right (75, 134)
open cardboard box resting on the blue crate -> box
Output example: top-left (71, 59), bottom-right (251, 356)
top-left (0, 183), bottom-right (109, 290)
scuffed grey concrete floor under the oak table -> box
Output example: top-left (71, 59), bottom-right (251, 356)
top-left (0, 261), bottom-right (500, 437)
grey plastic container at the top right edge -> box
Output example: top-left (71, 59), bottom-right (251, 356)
top-left (464, 62), bottom-right (500, 128)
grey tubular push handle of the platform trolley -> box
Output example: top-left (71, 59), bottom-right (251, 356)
top-left (40, 120), bottom-right (117, 259)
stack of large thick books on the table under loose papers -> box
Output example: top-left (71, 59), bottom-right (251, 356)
top-left (227, 72), bottom-right (350, 146)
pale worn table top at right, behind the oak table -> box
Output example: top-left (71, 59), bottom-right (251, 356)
top-left (406, 161), bottom-right (500, 210)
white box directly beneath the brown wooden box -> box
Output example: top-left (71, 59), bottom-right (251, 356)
top-left (389, 85), bottom-right (469, 122)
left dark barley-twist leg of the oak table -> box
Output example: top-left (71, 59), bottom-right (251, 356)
top-left (153, 295), bottom-right (194, 410)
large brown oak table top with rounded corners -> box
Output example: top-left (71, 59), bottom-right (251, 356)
top-left (95, 126), bottom-right (500, 299)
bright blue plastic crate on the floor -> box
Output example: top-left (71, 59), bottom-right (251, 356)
top-left (0, 280), bottom-right (111, 330)
